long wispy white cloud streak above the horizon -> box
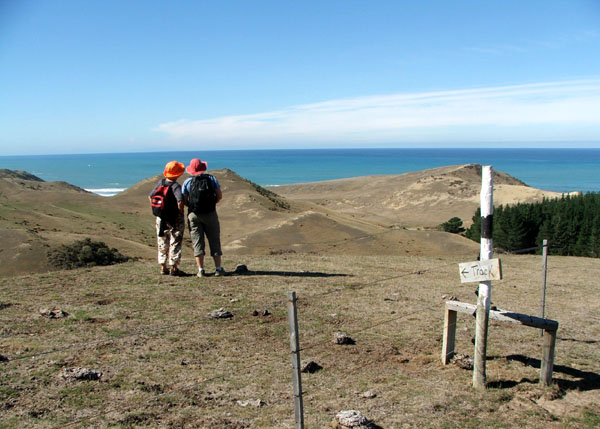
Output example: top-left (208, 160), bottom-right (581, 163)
top-left (155, 79), bottom-right (600, 146)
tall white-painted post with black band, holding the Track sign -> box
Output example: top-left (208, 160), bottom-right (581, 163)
top-left (473, 165), bottom-right (494, 389)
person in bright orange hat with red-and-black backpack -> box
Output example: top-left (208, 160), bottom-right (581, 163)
top-left (148, 161), bottom-right (185, 276)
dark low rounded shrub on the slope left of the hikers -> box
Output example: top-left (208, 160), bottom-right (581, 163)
top-left (48, 238), bottom-right (130, 270)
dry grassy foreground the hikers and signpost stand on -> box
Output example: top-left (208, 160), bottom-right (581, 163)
top-left (0, 254), bottom-right (600, 428)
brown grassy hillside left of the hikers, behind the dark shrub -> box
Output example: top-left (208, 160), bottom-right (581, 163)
top-left (0, 170), bottom-right (154, 276)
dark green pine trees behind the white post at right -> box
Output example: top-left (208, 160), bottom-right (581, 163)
top-left (465, 192), bottom-right (600, 258)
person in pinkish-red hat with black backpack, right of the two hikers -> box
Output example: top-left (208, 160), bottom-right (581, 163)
top-left (183, 158), bottom-right (225, 277)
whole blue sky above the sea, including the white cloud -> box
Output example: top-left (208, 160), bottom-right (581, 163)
top-left (0, 0), bottom-right (600, 155)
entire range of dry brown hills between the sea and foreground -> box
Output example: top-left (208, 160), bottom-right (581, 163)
top-left (0, 165), bottom-right (572, 276)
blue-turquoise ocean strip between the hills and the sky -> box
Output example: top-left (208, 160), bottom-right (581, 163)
top-left (0, 148), bottom-right (600, 196)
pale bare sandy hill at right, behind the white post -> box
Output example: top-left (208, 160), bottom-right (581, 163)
top-left (270, 164), bottom-right (560, 228)
